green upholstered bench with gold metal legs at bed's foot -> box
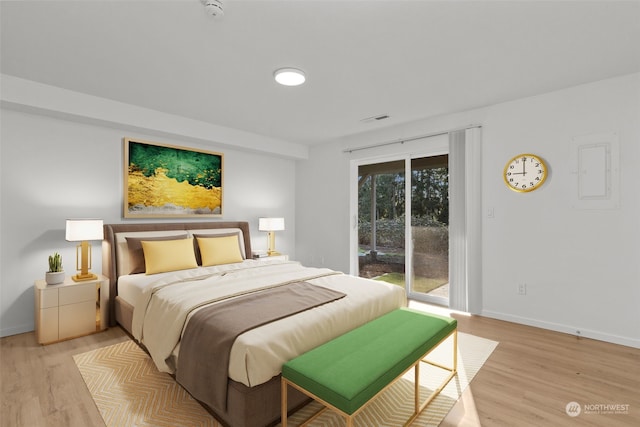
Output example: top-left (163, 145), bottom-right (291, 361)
top-left (282, 308), bottom-right (458, 427)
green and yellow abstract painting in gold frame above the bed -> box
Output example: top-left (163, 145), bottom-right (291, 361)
top-left (124, 138), bottom-right (222, 218)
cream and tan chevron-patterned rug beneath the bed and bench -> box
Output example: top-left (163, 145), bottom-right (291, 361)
top-left (73, 332), bottom-right (498, 427)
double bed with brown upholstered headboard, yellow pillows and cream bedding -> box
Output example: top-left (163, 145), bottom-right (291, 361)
top-left (102, 221), bottom-right (406, 427)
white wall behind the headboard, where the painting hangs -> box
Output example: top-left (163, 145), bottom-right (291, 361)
top-left (0, 109), bottom-right (295, 336)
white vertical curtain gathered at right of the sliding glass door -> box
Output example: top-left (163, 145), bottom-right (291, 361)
top-left (449, 127), bottom-right (482, 314)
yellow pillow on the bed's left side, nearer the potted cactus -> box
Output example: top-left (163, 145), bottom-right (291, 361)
top-left (141, 239), bottom-right (198, 274)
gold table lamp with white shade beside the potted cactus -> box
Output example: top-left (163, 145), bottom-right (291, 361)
top-left (65, 219), bottom-right (104, 282)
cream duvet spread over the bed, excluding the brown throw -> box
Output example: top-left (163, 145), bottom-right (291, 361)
top-left (132, 260), bottom-right (406, 387)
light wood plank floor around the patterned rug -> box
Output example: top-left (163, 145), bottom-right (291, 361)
top-left (0, 315), bottom-right (640, 427)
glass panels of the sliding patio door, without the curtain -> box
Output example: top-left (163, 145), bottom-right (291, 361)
top-left (357, 154), bottom-right (449, 305)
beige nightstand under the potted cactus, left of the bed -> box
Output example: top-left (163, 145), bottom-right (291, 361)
top-left (34, 274), bottom-right (109, 344)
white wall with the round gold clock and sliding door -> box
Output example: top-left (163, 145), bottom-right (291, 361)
top-left (296, 74), bottom-right (640, 347)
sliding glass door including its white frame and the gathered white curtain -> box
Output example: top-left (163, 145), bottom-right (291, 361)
top-left (352, 126), bottom-right (482, 313)
